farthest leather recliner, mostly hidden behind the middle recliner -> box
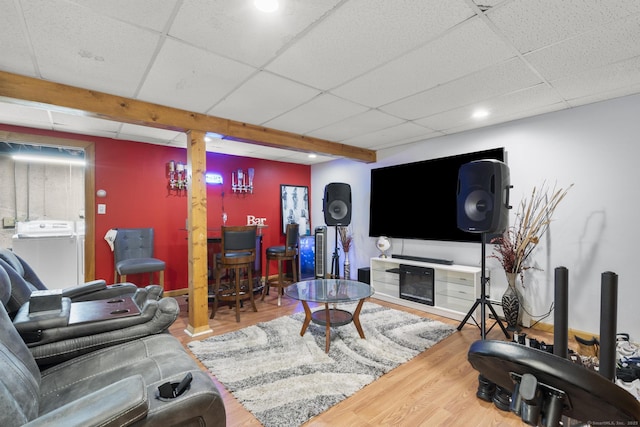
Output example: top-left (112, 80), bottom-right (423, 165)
top-left (0, 248), bottom-right (163, 317)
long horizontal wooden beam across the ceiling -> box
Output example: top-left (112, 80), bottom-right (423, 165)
top-left (0, 71), bottom-right (376, 163)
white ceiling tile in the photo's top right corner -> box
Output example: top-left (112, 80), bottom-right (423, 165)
top-left (486, 0), bottom-right (640, 53)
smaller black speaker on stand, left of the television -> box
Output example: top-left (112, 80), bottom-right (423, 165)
top-left (322, 182), bottom-right (351, 278)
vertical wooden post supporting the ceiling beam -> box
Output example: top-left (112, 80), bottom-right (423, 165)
top-left (185, 130), bottom-right (211, 336)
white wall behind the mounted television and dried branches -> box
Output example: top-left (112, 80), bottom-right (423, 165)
top-left (311, 95), bottom-right (640, 341)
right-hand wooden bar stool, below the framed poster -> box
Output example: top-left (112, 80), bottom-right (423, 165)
top-left (261, 224), bottom-right (299, 305)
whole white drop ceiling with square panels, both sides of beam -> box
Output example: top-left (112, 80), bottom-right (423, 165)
top-left (0, 0), bottom-right (640, 164)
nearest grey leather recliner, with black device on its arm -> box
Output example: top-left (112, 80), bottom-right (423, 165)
top-left (0, 269), bottom-right (226, 427)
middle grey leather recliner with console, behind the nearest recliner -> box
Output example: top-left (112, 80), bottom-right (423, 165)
top-left (0, 260), bottom-right (180, 367)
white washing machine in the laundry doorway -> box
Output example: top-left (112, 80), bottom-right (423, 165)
top-left (12, 220), bottom-right (84, 289)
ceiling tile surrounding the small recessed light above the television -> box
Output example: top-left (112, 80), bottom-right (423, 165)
top-left (415, 84), bottom-right (567, 133)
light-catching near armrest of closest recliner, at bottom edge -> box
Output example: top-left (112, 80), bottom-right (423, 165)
top-left (25, 375), bottom-right (149, 427)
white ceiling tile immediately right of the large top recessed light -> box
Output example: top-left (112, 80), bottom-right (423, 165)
top-left (266, 0), bottom-right (473, 90)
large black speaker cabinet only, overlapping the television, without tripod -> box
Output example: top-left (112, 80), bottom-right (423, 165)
top-left (457, 160), bottom-right (510, 233)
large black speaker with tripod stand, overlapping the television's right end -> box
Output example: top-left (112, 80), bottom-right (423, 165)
top-left (457, 159), bottom-right (511, 340)
